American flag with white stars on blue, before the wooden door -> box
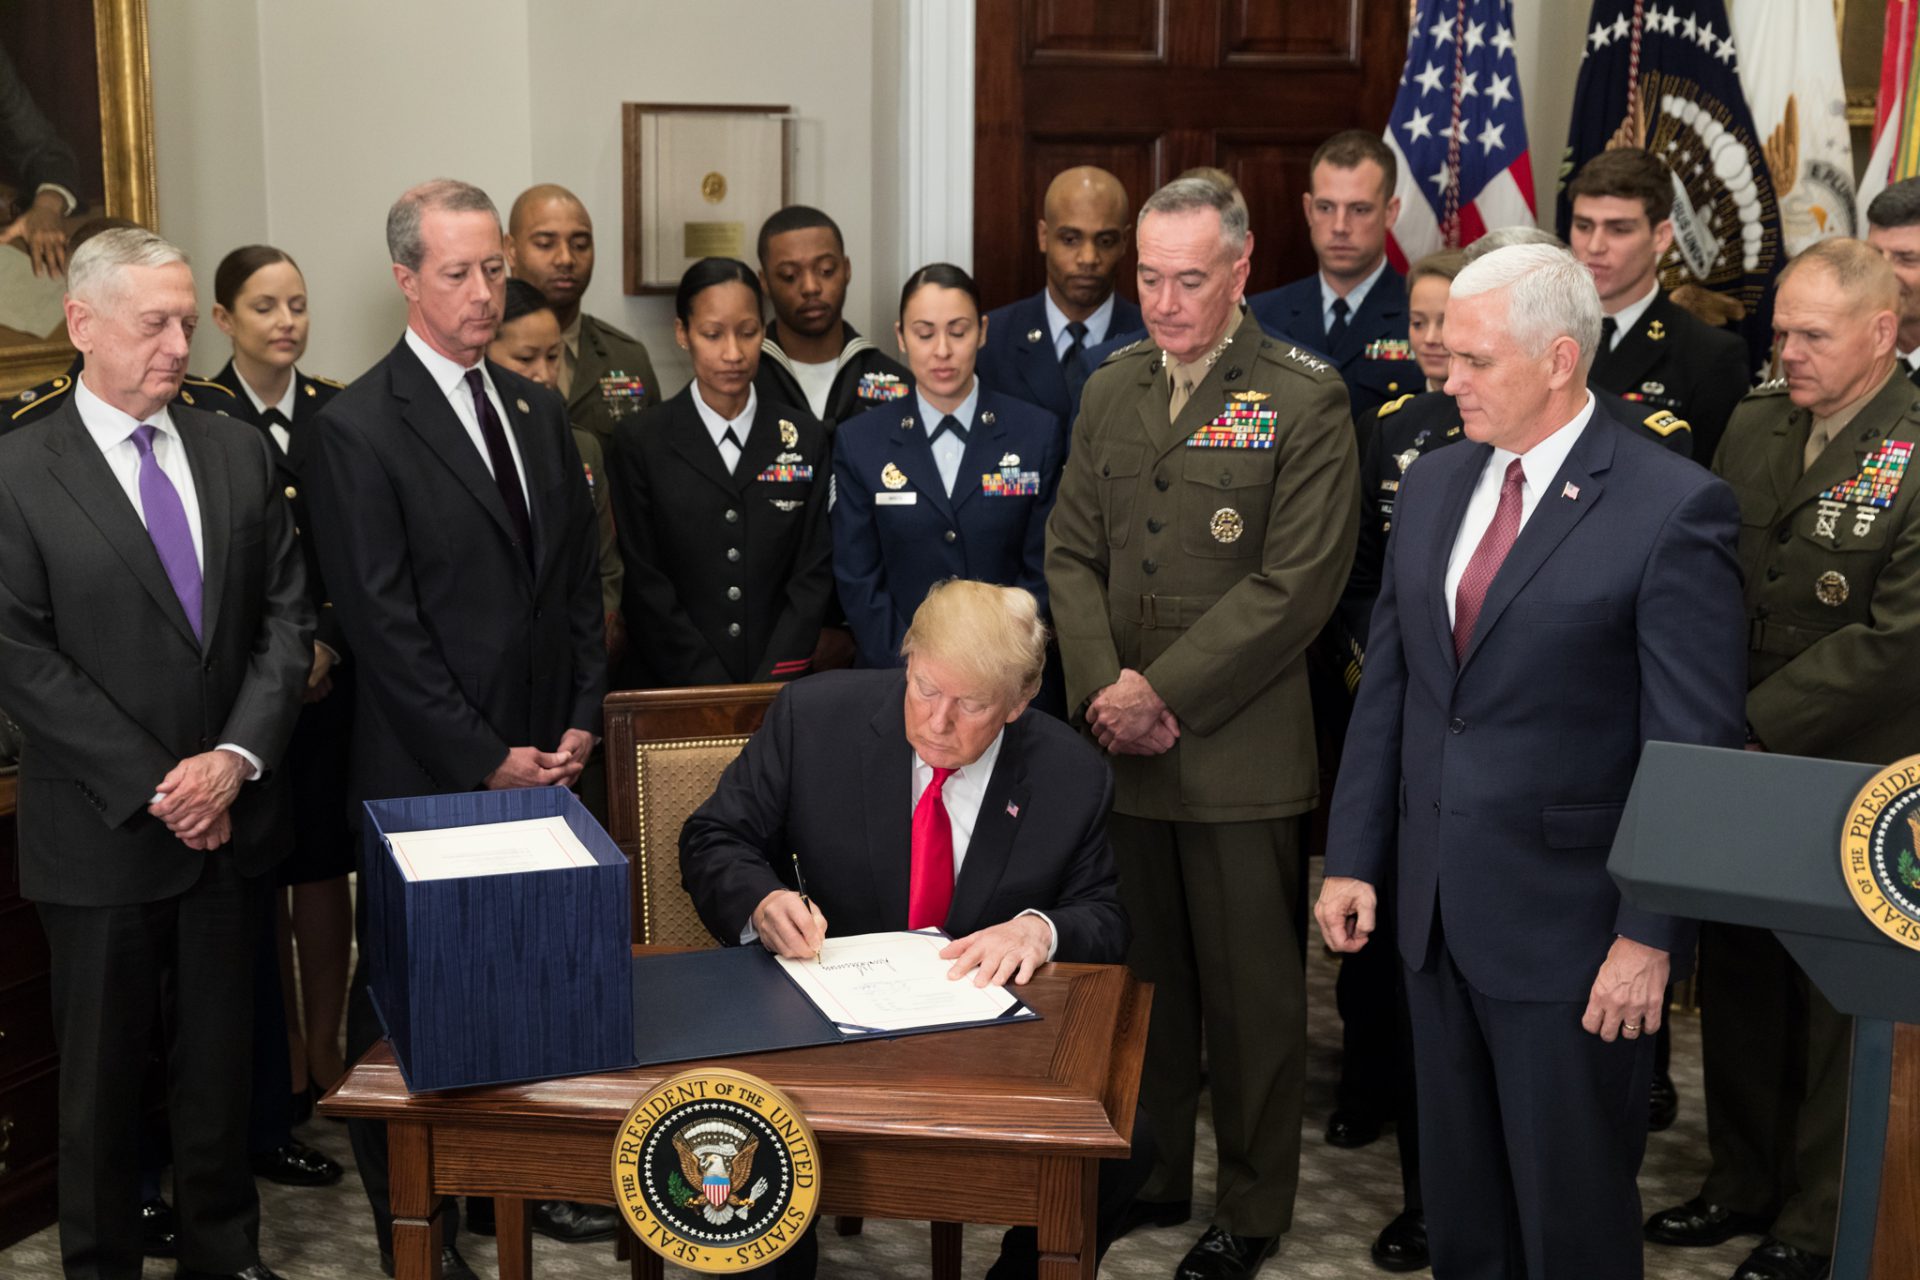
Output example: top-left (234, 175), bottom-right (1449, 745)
top-left (1386, 0), bottom-right (1534, 271)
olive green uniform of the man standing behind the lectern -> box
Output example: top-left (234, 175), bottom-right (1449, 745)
top-left (1699, 370), bottom-right (1920, 1255)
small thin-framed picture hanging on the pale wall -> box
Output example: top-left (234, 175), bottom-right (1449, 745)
top-left (620, 102), bottom-right (793, 294)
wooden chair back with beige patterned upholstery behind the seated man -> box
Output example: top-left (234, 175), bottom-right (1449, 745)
top-left (605, 685), bottom-right (780, 946)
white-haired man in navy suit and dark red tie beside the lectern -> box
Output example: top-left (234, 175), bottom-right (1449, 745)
top-left (1315, 246), bottom-right (1745, 1280)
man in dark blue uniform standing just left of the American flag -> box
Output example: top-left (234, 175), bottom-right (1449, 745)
top-left (1248, 129), bottom-right (1427, 427)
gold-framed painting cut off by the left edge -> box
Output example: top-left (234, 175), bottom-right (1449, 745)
top-left (0, 0), bottom-right (154, 393)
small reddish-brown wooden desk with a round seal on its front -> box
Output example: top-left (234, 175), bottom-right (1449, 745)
top-left (321, 948), bottom-right (1152, 1280)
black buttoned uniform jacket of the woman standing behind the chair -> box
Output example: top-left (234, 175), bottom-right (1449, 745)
top-left (611, 382), bottom-right (833, 689)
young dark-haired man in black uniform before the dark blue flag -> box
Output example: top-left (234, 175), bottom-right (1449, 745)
top-left (1567, 148), bottom-right (1753, 466)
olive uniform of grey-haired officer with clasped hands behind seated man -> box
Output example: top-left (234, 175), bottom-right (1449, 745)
top-left (1046, 305), bottom-right (1359, 1236)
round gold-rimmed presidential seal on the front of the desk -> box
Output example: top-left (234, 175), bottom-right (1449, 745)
top-left (612, 1067), bottom-right (820, 1272)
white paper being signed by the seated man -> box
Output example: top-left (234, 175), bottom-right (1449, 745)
top-left (780, 933), bottom-right (1020, 1031)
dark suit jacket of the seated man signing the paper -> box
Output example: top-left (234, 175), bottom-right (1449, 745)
top-left (680, 672), bottom-right (1129, 963)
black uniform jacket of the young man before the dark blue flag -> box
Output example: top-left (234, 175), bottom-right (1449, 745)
top-left (1588, 290), bottom-right (1753, 466)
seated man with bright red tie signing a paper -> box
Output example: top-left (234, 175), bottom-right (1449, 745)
top-left (680, 580), bottom-right (1150, 1280)
